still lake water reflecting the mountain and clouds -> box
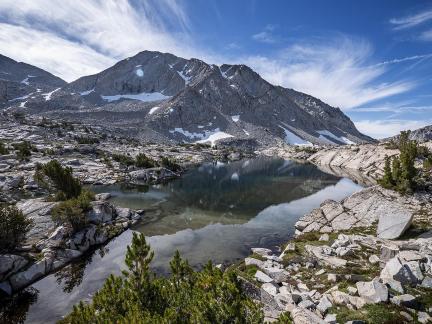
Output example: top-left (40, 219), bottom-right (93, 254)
top-left (11, 158), bottom-right (360, 323)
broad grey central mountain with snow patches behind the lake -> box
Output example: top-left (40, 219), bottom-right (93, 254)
top-left (0, 51), bottom-right (372, 145)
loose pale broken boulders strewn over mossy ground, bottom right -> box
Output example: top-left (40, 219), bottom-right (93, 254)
top-left (242, 234), bottom-right (432, 323)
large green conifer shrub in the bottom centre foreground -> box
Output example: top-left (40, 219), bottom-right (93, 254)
top-left (60, 233), bottom-right (263, 323)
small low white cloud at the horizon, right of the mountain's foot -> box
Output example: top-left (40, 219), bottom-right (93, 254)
top-left (354, 119), bottom-right (432, 139)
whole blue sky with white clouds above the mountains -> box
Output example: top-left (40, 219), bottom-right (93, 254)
top-left (0, 0), bottom-right (432, 138)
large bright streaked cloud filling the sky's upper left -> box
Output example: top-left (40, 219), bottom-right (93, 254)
top-left (0, 0), bottom-right (196, 81)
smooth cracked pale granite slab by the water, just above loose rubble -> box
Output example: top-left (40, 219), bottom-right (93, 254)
top-left (295, 186), bottom-right (430, 239)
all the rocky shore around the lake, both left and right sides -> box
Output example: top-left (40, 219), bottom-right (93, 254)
top-left (0, 114), bottom-right (432, 323)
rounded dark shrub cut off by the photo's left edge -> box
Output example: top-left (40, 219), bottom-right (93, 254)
top-left (0, 204), bottom-right (32, 252)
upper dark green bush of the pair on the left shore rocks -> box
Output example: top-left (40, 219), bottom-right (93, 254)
top-left (34, 160), bottom-right (82, 200)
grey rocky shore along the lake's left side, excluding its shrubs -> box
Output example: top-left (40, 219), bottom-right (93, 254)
top-left (0, 113), bottom-right (250, 295)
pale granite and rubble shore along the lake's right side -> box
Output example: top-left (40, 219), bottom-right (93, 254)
top-left (237, 143), bottom-right (432, 324)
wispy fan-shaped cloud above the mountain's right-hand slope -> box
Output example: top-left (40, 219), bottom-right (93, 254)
top-left (245, 36), bottom-right (415, 110)
